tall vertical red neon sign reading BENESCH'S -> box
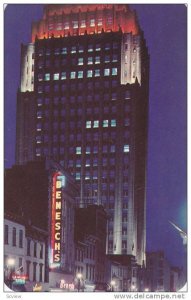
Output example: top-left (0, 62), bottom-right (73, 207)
top-left (51, 172), bottom-right (65, 266)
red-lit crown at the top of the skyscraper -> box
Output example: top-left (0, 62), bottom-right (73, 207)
top-left (32, 4), bottom-right (139, 42)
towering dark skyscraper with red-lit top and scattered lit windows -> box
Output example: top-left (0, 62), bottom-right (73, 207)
top-left (16, 4), bottom-right (149, 265)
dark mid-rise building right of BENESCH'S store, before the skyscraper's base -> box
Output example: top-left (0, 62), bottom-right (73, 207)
top-left (74, 205), bottom-right (107, 288)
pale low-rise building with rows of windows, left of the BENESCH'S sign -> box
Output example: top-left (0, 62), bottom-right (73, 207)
top-left (4, 212), bottom-right (48, 291)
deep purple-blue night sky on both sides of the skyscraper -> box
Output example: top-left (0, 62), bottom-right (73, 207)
top-left (4, 4), bottom-right (187, 266)
